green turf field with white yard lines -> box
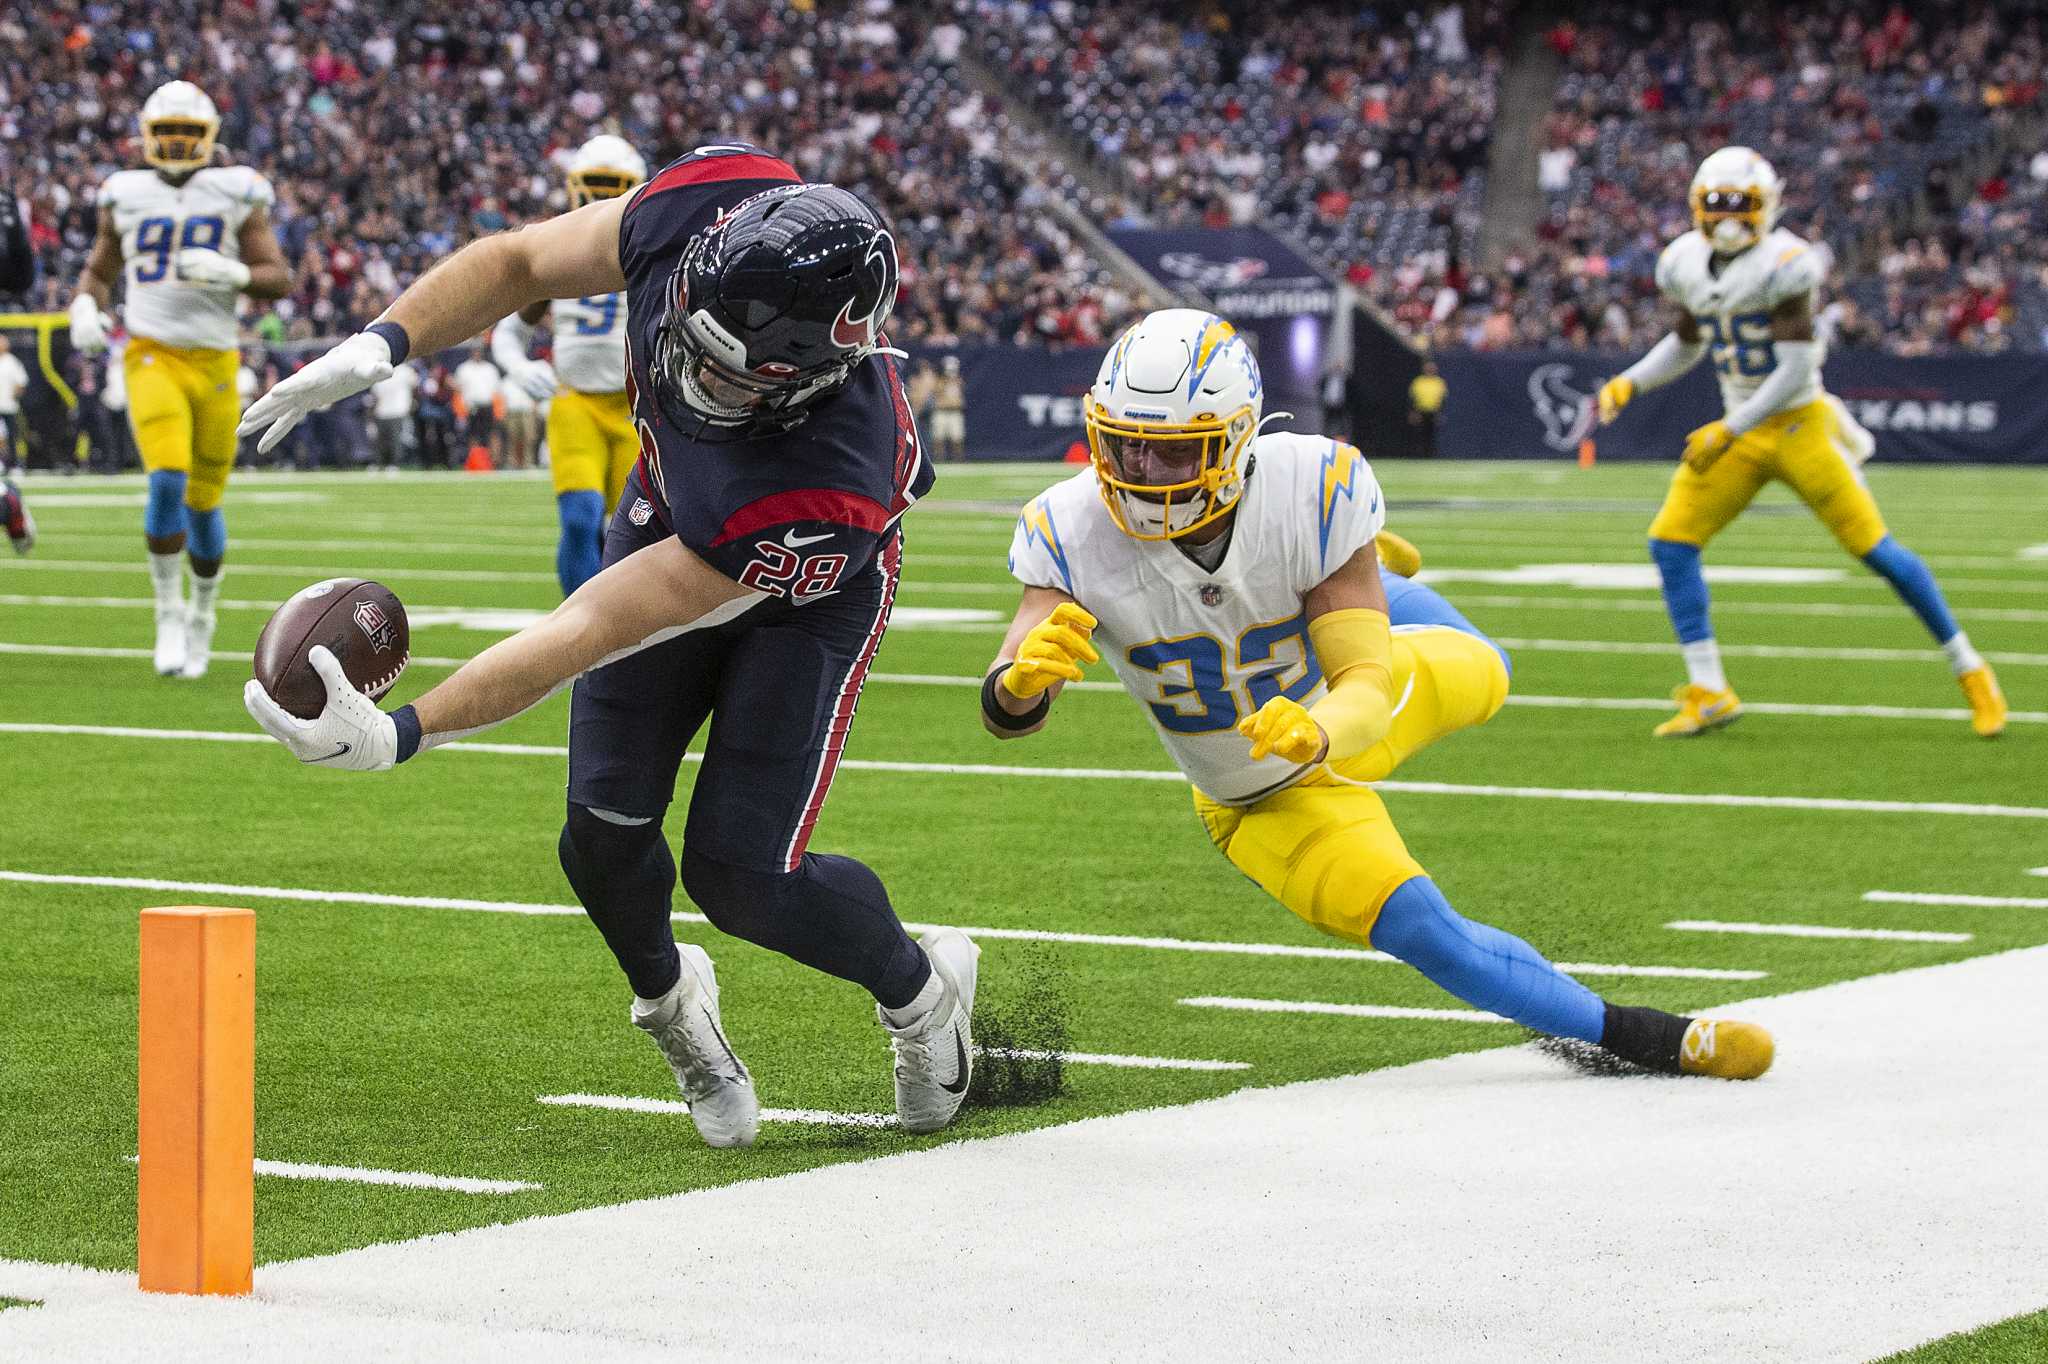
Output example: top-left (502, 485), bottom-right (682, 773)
top-left (0, 465), bottom-right (2048, 1318)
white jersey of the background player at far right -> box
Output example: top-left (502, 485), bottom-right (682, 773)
top-left (1657, 227), bottom-right (1831, 412)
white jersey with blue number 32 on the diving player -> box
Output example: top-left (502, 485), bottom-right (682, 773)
top-left (1010, 432), bottom-right (1386, 805)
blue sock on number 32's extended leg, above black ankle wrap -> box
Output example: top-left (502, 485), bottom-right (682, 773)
top-left (1372, 877), bottom-right (1608, 1042)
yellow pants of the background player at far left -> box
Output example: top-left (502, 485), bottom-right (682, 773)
top-left (121, 336), bottom-right (242, 512)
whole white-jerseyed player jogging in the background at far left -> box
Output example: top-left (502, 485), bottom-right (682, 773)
top-left (72, 80), bottom-right (291, 678)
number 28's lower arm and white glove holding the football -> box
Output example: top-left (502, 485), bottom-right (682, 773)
top-left (242, 539), bottom-right (762, 772)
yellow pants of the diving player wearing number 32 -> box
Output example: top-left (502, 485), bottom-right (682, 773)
top-left (1194, 625), bottom-right (1507, 944)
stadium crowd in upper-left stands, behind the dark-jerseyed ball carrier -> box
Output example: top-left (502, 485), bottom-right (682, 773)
top-left (0, 0), bottom-right (1133, 356)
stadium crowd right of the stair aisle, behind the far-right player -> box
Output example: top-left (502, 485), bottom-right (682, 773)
top-left (1368, 0), bottom-right (2048, 354)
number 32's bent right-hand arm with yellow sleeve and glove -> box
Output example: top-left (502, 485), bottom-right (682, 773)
top-left (1237, 543), bottom-right (1395, 762)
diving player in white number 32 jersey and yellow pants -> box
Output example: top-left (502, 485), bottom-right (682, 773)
top-left (981, 307), bottom-right (1774, 1079)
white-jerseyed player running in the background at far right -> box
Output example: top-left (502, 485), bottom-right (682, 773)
top-left (1597, 147), bottom-right (2005, 739)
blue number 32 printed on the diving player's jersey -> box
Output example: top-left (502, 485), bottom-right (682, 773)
top-left (1130, 612), bottom-right (1323, 733)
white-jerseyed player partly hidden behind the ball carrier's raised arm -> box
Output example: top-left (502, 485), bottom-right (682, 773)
top-left (492, 133), bottom-right (647, 596)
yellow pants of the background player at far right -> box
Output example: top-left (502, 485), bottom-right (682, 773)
top-left (1651, 395), bottom-right (1884, 559)
